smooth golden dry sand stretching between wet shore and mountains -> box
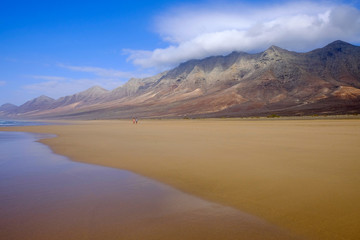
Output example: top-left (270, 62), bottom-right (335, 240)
top-left (1, 120), bottom-right (360, 239)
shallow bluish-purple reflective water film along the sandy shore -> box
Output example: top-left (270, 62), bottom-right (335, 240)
top-left (0, 130), bottom-right (297, 240)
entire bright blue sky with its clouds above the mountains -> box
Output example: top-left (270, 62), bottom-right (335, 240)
top-left (0, 0), bottom-right (360, 105)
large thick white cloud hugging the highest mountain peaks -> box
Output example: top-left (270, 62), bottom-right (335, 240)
top-left (126, 2), bottom-right (360, 69)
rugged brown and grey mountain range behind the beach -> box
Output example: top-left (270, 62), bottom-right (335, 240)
top-left (0, 41), bottom-right (360, 119)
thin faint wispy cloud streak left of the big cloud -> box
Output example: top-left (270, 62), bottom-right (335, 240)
top-left (58, 64), bottom-right (133, 78)
